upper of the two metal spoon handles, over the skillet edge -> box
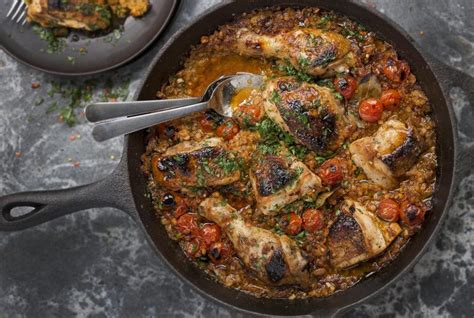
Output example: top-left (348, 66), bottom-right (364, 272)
top-left (84, 97), bottom-right (201, 123)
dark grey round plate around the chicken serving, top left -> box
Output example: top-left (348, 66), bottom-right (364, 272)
top-left (0, 0), bottom-right (178, 76)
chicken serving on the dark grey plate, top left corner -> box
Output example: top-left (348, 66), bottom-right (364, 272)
top-left (26, 0), bottom-right (149, 31)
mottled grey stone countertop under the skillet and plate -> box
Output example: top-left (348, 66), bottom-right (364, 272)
top-left (0, 0), bottom-right (474, 317)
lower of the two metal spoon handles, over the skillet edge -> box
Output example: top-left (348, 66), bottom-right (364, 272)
top-left (92, 102), bottom-right (208, 141)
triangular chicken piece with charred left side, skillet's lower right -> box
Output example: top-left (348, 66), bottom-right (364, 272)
top-left (328, 199), bottom-right (401, 268)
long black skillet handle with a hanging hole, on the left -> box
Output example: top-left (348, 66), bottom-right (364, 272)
top-left (0, 164), bottom-right (133, 231)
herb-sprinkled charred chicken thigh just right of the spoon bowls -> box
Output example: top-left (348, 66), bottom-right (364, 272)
top-left (263, 77), bottom-right (350, 152)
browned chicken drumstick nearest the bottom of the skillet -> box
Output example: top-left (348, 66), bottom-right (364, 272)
top-left (199, 194), bottom-right (309, 286)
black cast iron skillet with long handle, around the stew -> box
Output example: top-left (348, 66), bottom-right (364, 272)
top-left (0, 0), bottom-right (474, 315)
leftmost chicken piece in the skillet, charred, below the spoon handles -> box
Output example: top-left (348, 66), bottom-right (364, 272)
top-left (152, 138), bottom-right (240, 190)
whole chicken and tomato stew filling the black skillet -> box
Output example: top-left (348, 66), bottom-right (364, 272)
top-left (142, 8), bottom-right (437, 299)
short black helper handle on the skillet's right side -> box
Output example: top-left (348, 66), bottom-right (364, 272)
top-left (426, 54), bottom-right (474, 182)
